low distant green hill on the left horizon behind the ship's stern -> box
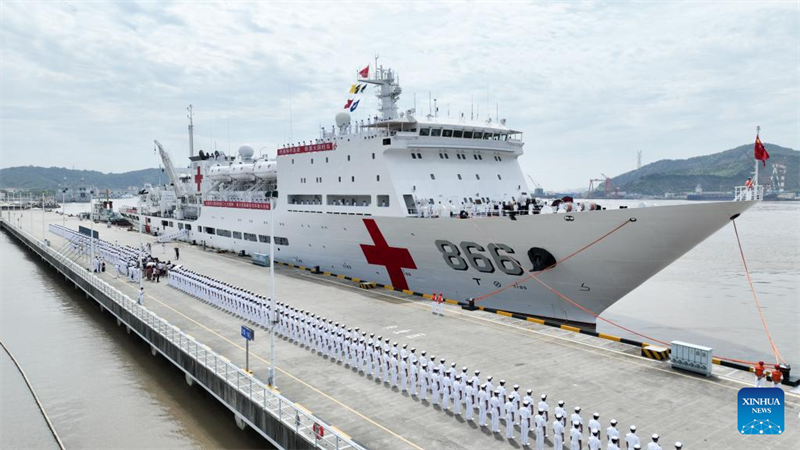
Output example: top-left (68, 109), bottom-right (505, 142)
top-left (0, 166), bottom-right (162, 191)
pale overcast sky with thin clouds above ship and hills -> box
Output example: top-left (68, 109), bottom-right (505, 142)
top-left (0, 1), bottom-right (800, 189)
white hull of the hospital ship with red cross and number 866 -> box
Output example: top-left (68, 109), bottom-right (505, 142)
top-left (129, 201), bottom-right (755, 323)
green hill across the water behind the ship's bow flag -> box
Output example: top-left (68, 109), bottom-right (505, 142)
top-left (613, 144), bottom-right (800, 196)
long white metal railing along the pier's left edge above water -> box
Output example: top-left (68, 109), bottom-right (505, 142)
top-left (6, 221), bottom-right (365, 450)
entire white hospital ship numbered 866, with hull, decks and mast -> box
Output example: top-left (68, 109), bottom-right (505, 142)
top-left (121, 62), bottom-right (760, 323)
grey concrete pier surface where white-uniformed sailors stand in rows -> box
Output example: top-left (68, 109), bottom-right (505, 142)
top-left (1, 211), bottom-right (800, 449)
